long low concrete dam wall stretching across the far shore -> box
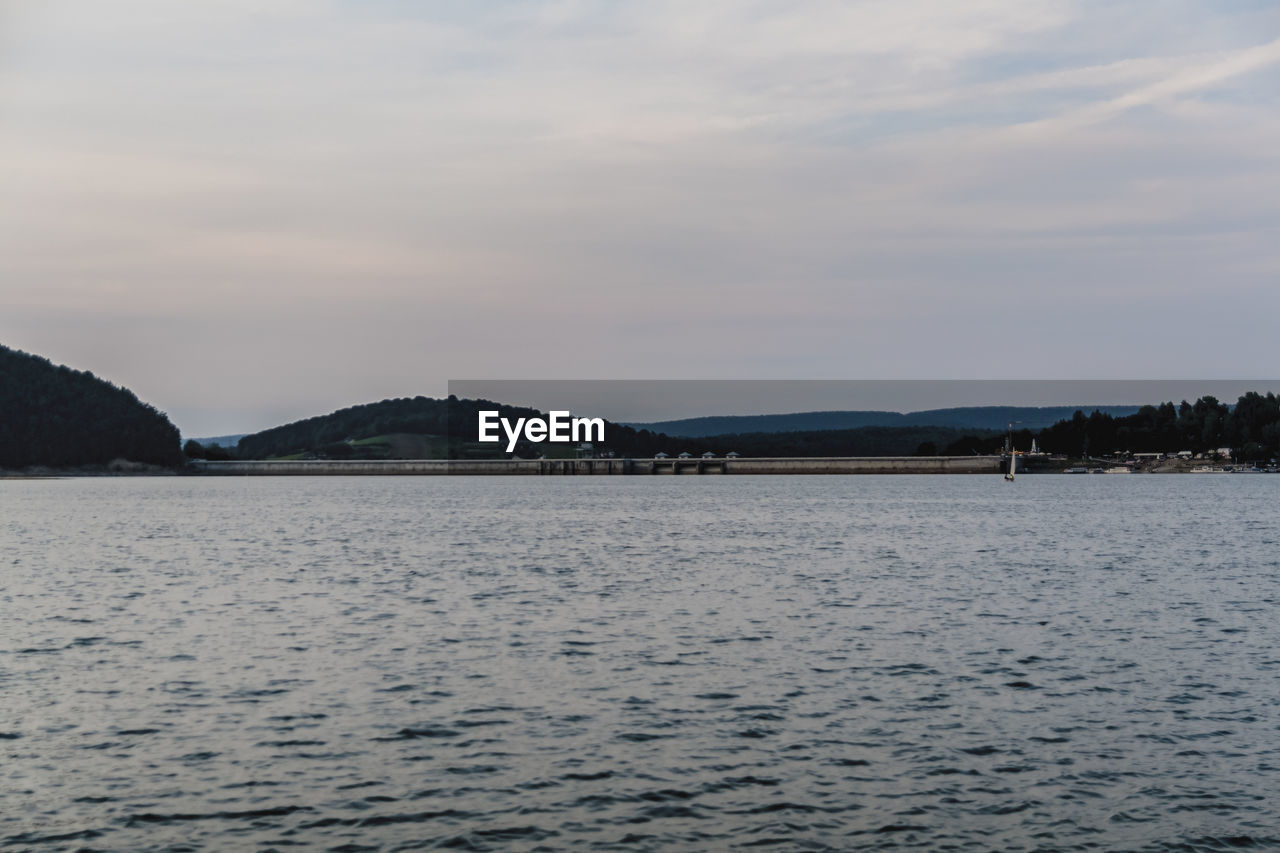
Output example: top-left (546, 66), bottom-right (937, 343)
top-left (189, 456), bottom-right (1004, 476)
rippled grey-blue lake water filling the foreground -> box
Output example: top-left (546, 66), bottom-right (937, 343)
top-left (0, 476), bottom-right (1280, 850)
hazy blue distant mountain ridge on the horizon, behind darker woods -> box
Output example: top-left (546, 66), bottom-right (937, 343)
top-left (626, 405), bottom-right (1140, 438)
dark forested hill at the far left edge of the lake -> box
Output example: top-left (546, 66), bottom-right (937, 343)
top-left (0, 346), bottom-right (182, 469)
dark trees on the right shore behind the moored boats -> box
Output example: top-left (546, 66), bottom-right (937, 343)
top-left (1039, 391), bottom-right (1280, 460)
